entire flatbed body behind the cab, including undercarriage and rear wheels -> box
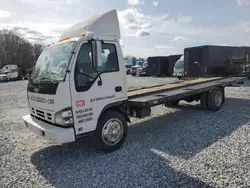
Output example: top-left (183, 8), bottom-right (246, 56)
top-left (128, 77), bottom-right (246, 118)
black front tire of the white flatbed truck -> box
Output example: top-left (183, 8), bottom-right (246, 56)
top-left (94, 110), bottom-right (128, 153)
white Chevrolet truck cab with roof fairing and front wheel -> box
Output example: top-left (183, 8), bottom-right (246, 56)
top-left (23, 10), bottom-right (127, 150)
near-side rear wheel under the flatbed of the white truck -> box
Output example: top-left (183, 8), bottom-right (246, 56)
top-left (207, 88), bottom-right (224, 111)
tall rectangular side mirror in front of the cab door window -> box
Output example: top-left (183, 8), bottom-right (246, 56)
top-left (92, 40), bottom-right (102, 70)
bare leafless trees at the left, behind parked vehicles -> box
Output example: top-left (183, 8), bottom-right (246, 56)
top-left (0, 29), bottom-right (44, 72)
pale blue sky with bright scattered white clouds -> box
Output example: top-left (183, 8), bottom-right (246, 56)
top-left (0, 0), bottom-right (250, 58)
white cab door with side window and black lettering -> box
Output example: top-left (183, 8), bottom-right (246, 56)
top-left (70, 42), bottom-right (127, 135)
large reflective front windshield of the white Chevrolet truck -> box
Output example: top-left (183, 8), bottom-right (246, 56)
top-left (30, 42), bottom-right (76, 82)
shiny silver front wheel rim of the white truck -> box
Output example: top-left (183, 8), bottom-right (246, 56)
top-left (102, 119), bottom-right (123, 146)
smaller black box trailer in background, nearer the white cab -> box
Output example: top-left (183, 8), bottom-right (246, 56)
top-left (148, 55), bottom-right (182, 76)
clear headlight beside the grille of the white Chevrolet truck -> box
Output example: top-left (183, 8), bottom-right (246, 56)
top-left (55, 108), bottom-right (74, 127)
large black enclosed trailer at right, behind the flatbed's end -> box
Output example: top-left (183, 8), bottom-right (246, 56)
top-left (184, 45), bottom-right (250, 77)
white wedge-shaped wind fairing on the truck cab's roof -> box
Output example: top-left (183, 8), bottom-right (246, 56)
top-left (59, 10), bottom-right (120, 40)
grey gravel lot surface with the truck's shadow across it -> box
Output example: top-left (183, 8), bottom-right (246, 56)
top-left (0, 76), bottom-right (250, 188)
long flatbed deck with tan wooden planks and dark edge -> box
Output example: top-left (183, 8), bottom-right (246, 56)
top-left (128, 77), bottom-right (246, 107)
